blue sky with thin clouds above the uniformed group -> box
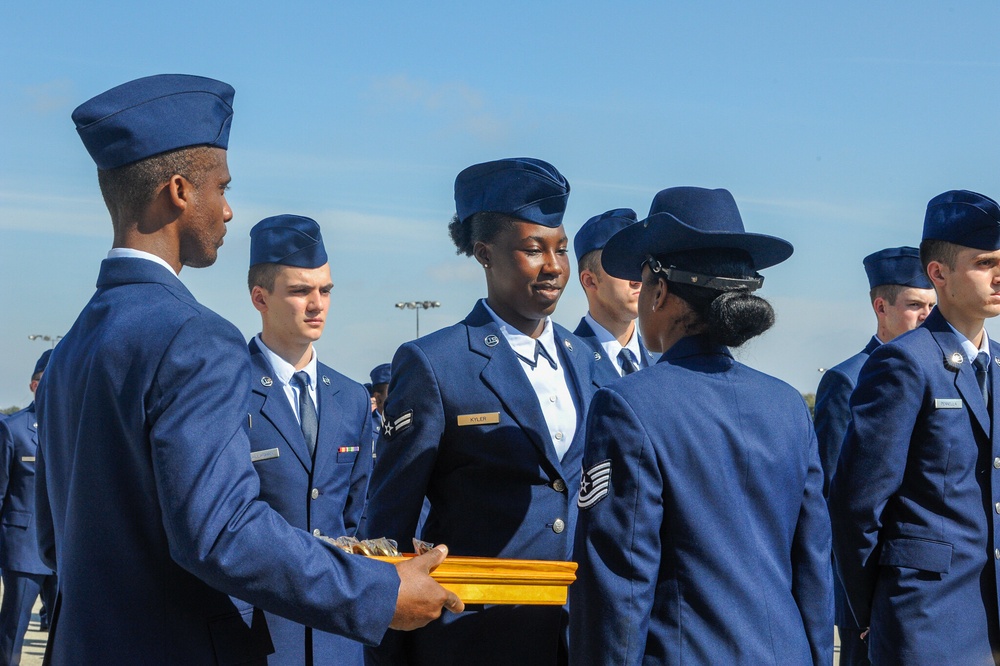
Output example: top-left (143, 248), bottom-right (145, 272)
top-left (0, 5), bottom-right (1000, 406)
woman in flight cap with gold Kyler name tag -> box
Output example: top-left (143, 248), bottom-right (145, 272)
top-left (366, 158), bottom-right (595, 664)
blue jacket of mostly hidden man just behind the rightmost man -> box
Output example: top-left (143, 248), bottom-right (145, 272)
top-left (815, 336), bottom-right (882, 640)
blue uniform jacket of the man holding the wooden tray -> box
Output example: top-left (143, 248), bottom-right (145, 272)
top-left (36, 258), bottom-right (399, 665)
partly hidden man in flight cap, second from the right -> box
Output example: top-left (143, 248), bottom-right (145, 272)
top-left (816, 247), bottom-right (936, 666)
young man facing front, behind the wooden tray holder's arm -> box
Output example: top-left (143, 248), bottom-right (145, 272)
top-left (246, 215), bottom-right (372, 666)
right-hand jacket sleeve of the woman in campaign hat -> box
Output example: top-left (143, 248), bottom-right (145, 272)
top-left (792, 415), bottom-right (834, 665)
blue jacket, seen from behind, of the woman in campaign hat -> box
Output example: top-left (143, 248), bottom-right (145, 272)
top-left (570, 336), bottom-right (833, 666)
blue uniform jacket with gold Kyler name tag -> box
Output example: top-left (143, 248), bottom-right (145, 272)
top-left (366, 302), bottom-right (596, 664)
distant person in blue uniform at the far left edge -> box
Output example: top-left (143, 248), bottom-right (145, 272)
top-left (0, 349), bottom-right (56, 664)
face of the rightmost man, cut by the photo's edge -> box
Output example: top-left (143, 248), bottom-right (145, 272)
top-left (929, 248), bottom-right (1000, 319)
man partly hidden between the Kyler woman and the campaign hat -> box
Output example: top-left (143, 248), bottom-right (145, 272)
top-left (573, 208), bottom-right (652, 386)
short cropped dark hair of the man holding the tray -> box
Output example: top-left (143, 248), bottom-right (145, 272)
top-left (97, 146), bottom-right (213, 224)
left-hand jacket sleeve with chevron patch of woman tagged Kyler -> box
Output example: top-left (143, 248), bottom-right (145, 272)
top-left (364, 343), bottom-right (444, 551)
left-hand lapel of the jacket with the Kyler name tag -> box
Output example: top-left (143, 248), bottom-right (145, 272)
top-left (465, 301), bottom-right (562, 475)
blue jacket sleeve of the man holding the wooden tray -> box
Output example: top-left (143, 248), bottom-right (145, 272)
top-left (146, 316), bottom-right (399, 644)
